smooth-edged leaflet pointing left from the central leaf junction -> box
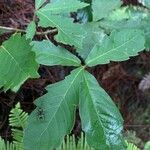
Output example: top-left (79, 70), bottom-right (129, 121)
top-left (33, 40), bottom-right (81, 66)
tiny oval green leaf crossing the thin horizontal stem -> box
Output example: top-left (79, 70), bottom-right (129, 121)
top-left (26, 21), bottom-right (36, 40)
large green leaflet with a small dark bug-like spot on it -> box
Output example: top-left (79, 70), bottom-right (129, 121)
top-left (24, 67), bottom-right (83, 150)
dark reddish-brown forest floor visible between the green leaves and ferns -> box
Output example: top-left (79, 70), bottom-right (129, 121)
top-left (0, 0), bottom-right (150, 148)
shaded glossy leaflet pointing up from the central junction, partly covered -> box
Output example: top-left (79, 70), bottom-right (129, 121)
top-left (77, 22), bottom-right (105, 59)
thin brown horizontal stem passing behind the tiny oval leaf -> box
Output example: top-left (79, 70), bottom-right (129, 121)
top-left (0, 26), bottom-right (57, 35)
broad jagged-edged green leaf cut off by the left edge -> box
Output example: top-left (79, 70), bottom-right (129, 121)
top-left (0, 34), bottom-right (38, 91)
